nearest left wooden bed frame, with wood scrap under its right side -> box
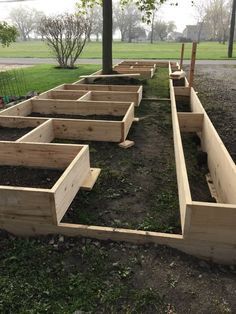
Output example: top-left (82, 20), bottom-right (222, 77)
top-left (0, 141), bottom-right (100, 229)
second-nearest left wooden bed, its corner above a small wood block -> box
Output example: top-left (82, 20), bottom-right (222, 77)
top-left (0, 98), bottom-right (134, 142)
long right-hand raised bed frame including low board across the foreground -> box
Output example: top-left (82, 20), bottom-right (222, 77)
top-left (0, 62), bottom-right (236, 264)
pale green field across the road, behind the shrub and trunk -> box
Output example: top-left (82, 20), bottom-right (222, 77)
top-left (0, 41), bottom-right (236, 60)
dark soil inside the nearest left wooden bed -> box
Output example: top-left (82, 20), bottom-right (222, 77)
top-left (0, 166), bottom-right (63, 189)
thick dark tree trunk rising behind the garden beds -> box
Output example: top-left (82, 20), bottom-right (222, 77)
top-left (102, 0), bottom-right (112, 74)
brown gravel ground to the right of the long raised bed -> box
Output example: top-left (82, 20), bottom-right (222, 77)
top-left (185, 65), bottom-right (236, 162)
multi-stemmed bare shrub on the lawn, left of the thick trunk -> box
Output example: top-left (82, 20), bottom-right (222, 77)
top-left (40, 14), bottom-right (88, 68)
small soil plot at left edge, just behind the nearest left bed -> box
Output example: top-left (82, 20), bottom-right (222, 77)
top-left (0, 116), bottom-right (46, 141)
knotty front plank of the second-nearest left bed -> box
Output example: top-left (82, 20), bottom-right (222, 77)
top-left (53, 119), bottom-right (123, 142)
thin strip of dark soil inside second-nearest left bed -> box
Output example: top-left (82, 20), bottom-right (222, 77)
top-left (28, 112), bottom-right (124, 121)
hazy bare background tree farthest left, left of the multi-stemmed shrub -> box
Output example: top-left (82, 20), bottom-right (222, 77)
top-left (9, 6), bottom-right (43, 41)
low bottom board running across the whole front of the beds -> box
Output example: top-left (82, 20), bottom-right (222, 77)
top-left (0, 220), bottom-right (236, 264)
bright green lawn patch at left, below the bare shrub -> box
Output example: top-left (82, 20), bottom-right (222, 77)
top-left (0, 64), bottom-right (100, 96)
